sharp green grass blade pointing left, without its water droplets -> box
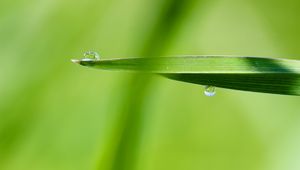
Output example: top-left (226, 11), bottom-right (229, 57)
top-left (73, 56), bottom-right (300, 95)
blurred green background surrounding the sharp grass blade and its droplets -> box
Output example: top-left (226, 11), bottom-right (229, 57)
top-left (0, 0), bottom-right (300, 170)
